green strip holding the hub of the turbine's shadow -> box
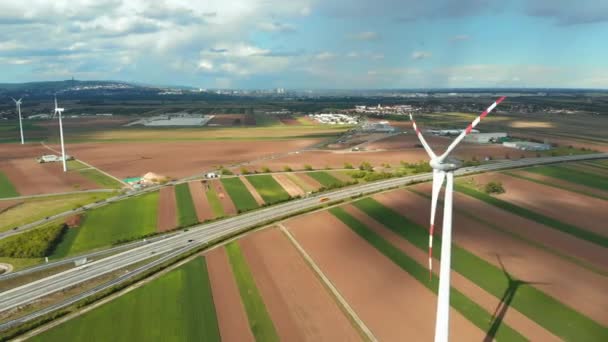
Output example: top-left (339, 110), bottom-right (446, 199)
top-left (354, 198), bottom-right (608, 341)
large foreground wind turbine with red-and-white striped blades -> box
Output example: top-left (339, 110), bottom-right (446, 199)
top-left (410, 96), bottom-right (506, 342)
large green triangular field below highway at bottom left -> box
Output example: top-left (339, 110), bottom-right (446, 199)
top-left (32, 257), bottom-right (220, 342)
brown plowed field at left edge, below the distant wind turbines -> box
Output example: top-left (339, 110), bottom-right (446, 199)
top-left (0, 144), bottom-right (99, 195)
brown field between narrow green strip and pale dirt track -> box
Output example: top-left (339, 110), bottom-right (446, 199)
top-left (239, 229), bottom-right (360, 341)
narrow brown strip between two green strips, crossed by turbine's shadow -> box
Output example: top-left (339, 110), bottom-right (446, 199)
top-left (343, 205), bottom-right (559, 341)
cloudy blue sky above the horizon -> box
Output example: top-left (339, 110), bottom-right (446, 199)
top-left (0, 0), bottom-right (608, 89)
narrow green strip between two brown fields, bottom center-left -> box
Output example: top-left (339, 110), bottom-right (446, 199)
top-left (226, 241), bottom-right (279, 342)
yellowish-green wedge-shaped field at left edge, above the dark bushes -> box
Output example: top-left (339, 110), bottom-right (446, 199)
top-left (0, 193), bottom-right (115, 232)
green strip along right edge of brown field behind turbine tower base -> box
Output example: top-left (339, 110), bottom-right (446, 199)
top-left (329, 207), bottom-right (526, 341)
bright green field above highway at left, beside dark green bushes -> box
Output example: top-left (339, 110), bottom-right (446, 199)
top-left (53, 192), bottom-right (158, 258)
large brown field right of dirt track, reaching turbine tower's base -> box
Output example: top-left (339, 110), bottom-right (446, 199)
top-left (287, 211), bottom-right (485, 341)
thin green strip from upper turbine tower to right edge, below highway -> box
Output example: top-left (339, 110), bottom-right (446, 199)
top-left (454, 183), bottom-right (608, 247)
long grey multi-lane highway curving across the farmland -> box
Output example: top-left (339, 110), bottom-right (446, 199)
top-left (0, 153), bottom-right (608, 329)
